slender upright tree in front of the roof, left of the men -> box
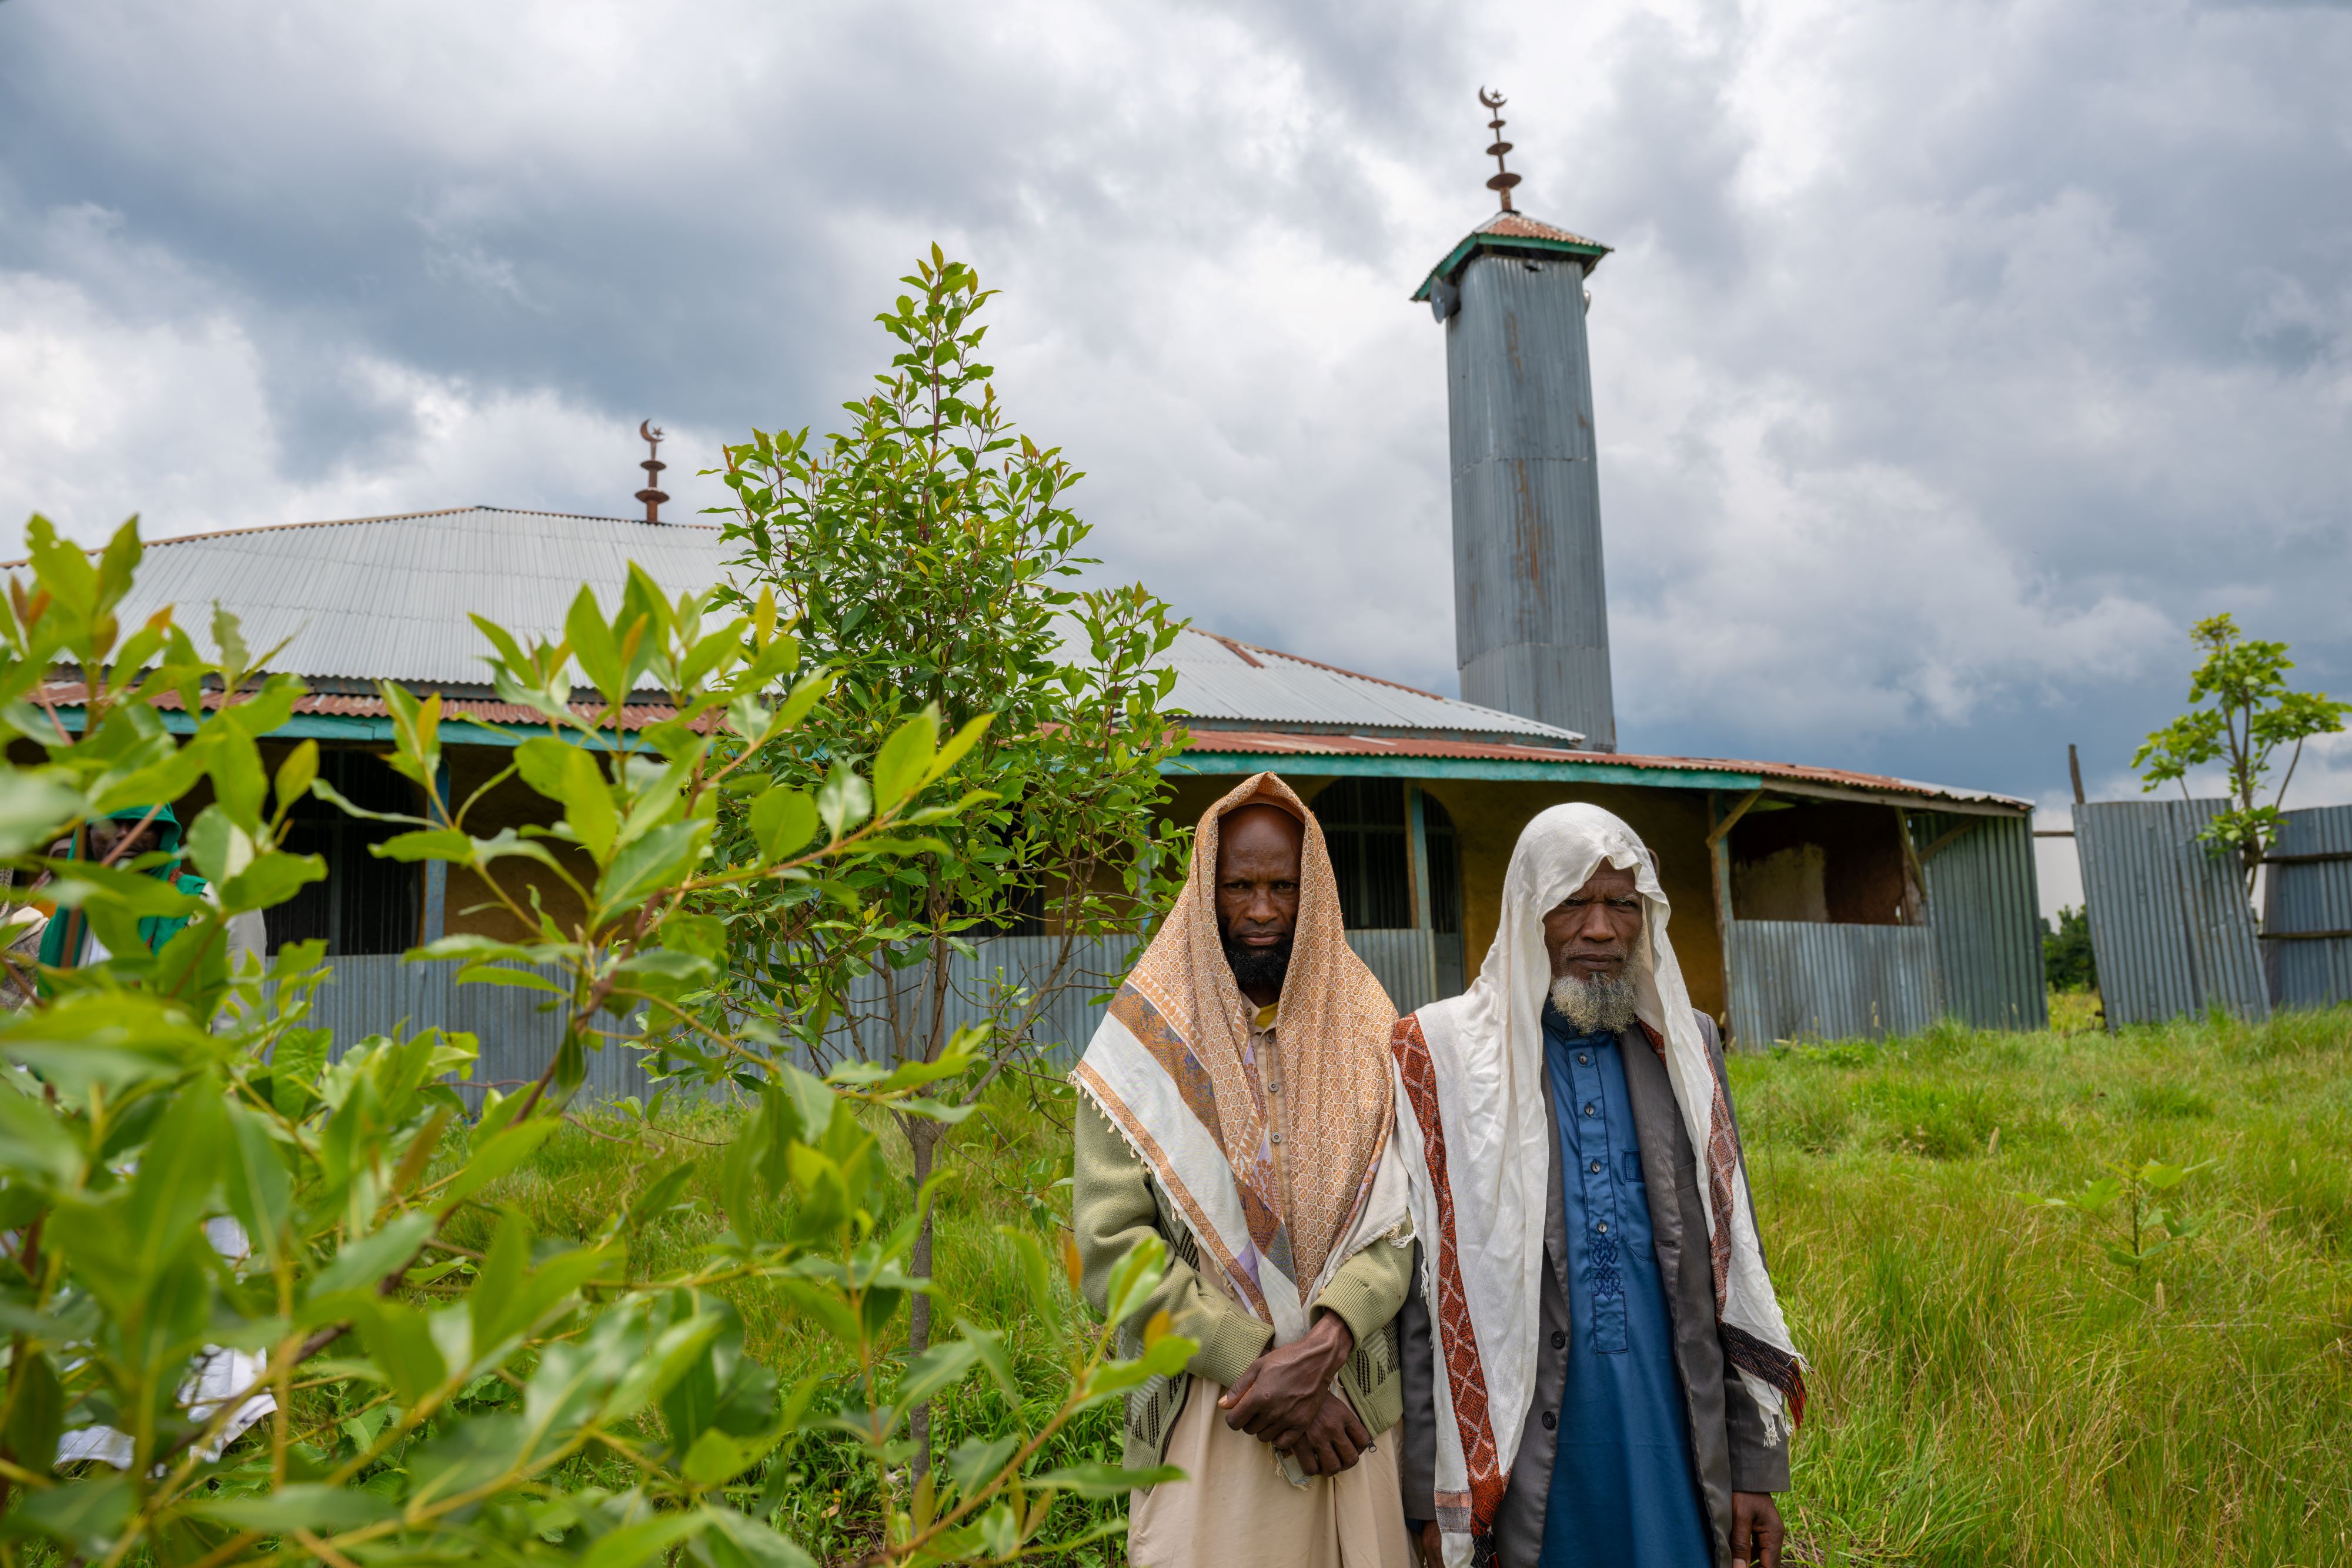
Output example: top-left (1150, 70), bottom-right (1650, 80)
top-left (708, 247), bottom-right (1183, 1472)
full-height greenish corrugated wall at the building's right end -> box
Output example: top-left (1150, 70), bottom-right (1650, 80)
top-left (1910, 811), bottom-right (2049, 1029)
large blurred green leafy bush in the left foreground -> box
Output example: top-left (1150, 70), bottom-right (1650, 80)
top-left (0, 517), bottom-right (1192, 1568)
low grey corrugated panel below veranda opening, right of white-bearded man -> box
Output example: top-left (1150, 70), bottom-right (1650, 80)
top-left (1729, 919), bottom-right (1938, 1048)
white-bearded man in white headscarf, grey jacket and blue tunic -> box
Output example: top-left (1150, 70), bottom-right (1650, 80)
top-left (1395, 804), bottom-right (1804, 1568)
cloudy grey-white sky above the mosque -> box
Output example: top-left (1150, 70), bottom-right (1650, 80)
top-left (0, 0), bottom-right (2352, 900)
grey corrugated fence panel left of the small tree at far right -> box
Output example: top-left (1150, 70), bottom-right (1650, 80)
top-left (2074, 799), bottom-right (2270, 1025)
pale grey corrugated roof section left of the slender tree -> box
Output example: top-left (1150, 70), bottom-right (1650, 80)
top-left (101, 506), bottom-right (727, 684)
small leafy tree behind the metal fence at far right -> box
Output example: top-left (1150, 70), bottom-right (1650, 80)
top-left (2131, 614), bottom-right (2352, 895)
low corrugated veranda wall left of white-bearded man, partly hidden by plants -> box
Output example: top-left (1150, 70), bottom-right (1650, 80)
top-left (294, 931), bottom-right (1458, 1100)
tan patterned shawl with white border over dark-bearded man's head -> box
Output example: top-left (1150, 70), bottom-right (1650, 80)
top-left (1073, 774), bottom-right (1404, 1345)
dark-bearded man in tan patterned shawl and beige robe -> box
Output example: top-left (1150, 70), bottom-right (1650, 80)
top-left (1073, 774), bottom-right (1414, 1568)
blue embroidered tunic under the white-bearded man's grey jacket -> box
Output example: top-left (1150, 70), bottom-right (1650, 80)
top-left (1541, 1008), bottom-right (1715, 1568)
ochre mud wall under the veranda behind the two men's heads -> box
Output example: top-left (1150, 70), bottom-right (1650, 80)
top-left (1167, 774), bottom-right (1731, 1018)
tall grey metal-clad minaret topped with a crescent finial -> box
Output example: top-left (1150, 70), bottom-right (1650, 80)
top-left (1414, 87), bottom-right (1616, 753)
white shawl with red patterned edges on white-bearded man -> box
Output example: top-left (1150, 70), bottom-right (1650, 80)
top-left (1395, 804), bottom-right (1804, 1563)
